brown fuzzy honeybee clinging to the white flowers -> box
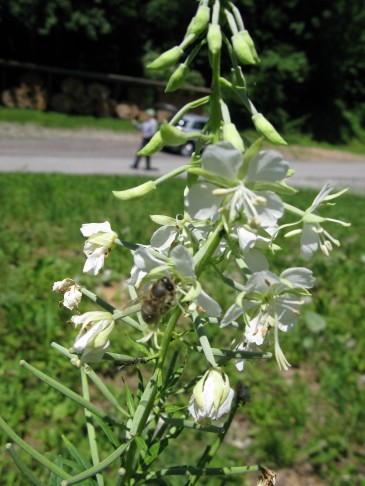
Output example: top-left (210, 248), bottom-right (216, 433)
top-left (141, 277), bottom-right (175, 324)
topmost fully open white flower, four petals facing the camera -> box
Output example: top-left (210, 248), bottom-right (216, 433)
top-left (185, 143), bottom-right (289, 235)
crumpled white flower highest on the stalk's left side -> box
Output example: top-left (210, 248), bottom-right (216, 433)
top-left (80, 221), bottom-right (118, 275)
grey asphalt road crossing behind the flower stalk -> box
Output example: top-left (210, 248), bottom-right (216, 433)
top-left (0, 131), bottom-right (365, 192)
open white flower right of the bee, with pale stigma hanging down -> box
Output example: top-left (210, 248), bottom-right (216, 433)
top-left (221, 267), bottom-right (315, 370)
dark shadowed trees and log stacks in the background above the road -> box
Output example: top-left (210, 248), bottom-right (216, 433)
top-left (0, 0), bottom-right (365, 144)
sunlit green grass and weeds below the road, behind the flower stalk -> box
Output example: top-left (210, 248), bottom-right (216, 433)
top-left (0, 174), bottom-right (365, 486)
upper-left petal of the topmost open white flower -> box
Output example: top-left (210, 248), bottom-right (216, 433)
top-left (202, 142), bottom-right (243, 179)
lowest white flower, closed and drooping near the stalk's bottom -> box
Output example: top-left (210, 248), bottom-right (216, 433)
top-left (188, 368), bottom-right (234, 423)
